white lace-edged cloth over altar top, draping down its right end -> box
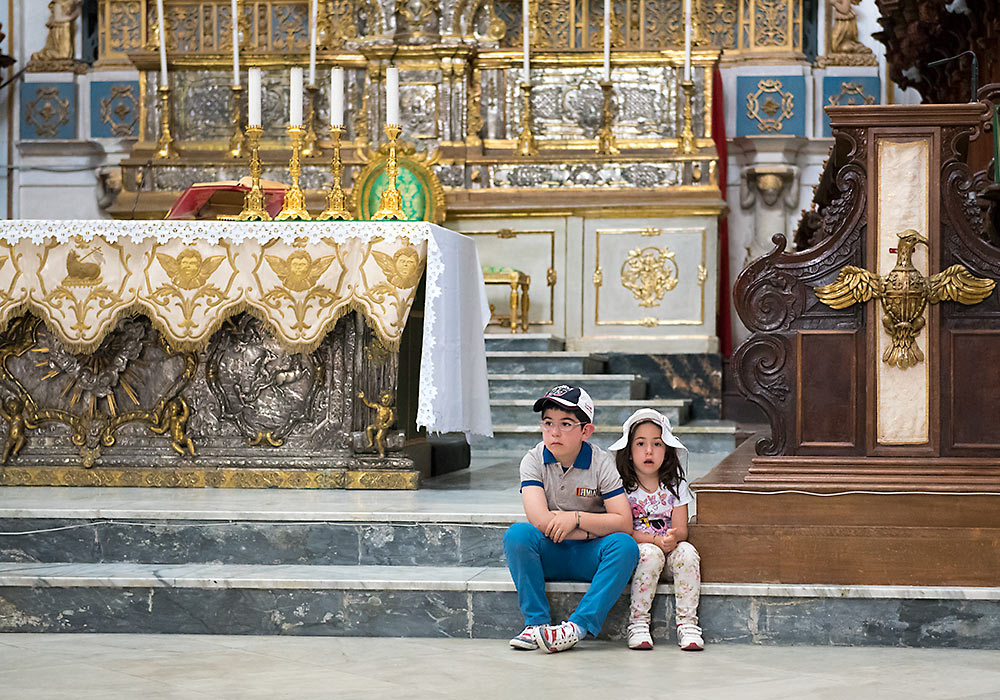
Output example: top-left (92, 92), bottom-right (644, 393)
top-left (0, 220), bottom-right (493, 436)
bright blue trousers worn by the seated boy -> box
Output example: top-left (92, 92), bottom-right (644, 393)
top-left (503, 523), bottom-right (639, 637)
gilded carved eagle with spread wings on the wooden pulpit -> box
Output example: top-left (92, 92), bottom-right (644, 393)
top-left (815, 229), bottom-right (996, 369)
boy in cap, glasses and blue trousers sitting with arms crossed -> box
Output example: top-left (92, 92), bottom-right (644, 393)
top-left (503, 385), bottom-right (639, 652)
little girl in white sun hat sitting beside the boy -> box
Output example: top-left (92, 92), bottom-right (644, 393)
top-left (609, 408), bottom-right (705, 651)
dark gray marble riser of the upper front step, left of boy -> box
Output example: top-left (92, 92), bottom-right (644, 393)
top-left (0, 516), bottom-right (508, 567)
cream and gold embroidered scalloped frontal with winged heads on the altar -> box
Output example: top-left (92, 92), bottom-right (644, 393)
top-left (0, 221), bottom-right (427, 353)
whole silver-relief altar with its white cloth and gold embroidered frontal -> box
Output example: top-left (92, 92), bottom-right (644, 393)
top-left (0, 221), bottom-right (491, 488)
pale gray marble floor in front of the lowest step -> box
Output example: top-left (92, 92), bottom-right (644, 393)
top-left (0, 634), bottom-right (1000, 700)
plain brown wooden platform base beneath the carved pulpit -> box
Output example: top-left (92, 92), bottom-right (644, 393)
top-left (689, 439), bottom-right (1000, 586)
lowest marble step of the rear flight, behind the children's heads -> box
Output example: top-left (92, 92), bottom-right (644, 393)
top-left (472, 422), bottom-right (737, 456)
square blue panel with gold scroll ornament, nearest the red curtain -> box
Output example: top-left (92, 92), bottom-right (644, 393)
top-left (736, 75), bottom-right (807, 136)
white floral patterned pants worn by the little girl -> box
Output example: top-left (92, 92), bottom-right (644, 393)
top-left (629, 542), bottom-right (701, 625)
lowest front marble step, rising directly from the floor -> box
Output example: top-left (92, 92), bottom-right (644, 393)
top-left (0, 563), bottom-right (1000, 648)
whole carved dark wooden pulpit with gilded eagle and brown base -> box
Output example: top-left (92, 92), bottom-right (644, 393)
top-left (692, 104), bottom-right (1000, 585)
